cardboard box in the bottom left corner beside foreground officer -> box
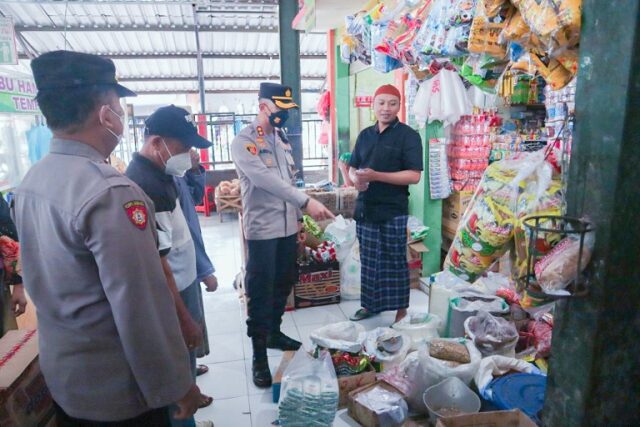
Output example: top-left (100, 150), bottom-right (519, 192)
top-left (0, 329), bottom-right (55, 427)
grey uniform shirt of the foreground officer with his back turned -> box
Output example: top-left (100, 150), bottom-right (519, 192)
top-left (12, 139), bottom-right (193, 421)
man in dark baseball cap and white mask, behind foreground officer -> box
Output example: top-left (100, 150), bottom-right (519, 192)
top-left (127, 105), bottom-right (212, 425)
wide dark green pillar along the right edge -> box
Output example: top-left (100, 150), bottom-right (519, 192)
top-left (543, 0), bottom-right (640, 426)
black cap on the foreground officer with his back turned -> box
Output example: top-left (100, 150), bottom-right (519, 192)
top-left (31, 50), bottom-right (136, 98)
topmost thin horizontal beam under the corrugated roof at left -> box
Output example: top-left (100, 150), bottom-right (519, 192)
top-left (15, 24), bottom-right (278, 33)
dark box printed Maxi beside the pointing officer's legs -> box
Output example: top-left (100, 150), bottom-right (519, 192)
top-left (293, 261), bottom-right (340, 308)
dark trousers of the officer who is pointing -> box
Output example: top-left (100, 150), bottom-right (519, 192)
top-left (245, 234), bottom-right (298, 337)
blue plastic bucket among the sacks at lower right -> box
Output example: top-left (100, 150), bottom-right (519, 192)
top-left (422, 377), bottom-right (480, 424)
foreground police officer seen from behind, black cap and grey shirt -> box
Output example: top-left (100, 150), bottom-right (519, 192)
top-left (12, 51), bottom-right (200, 426)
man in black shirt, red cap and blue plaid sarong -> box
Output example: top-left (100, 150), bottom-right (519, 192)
top-left (349, 85), bottom-right (423, 321)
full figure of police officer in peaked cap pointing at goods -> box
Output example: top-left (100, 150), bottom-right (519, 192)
top-left (231, 83), bottom-right (333, 387)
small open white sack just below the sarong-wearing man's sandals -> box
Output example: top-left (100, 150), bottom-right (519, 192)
top-left (364, 328), bottom-right (411, 370)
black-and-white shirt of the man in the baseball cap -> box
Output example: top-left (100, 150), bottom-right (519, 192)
top-left (127, 153), bottom-right (197, 291)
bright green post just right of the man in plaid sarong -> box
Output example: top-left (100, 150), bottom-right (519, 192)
top-left (409, 122), bottom-right (444, 276)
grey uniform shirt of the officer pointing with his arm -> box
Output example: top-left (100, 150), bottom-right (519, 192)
top-left (231, 122), bottom-right (309, 240)
